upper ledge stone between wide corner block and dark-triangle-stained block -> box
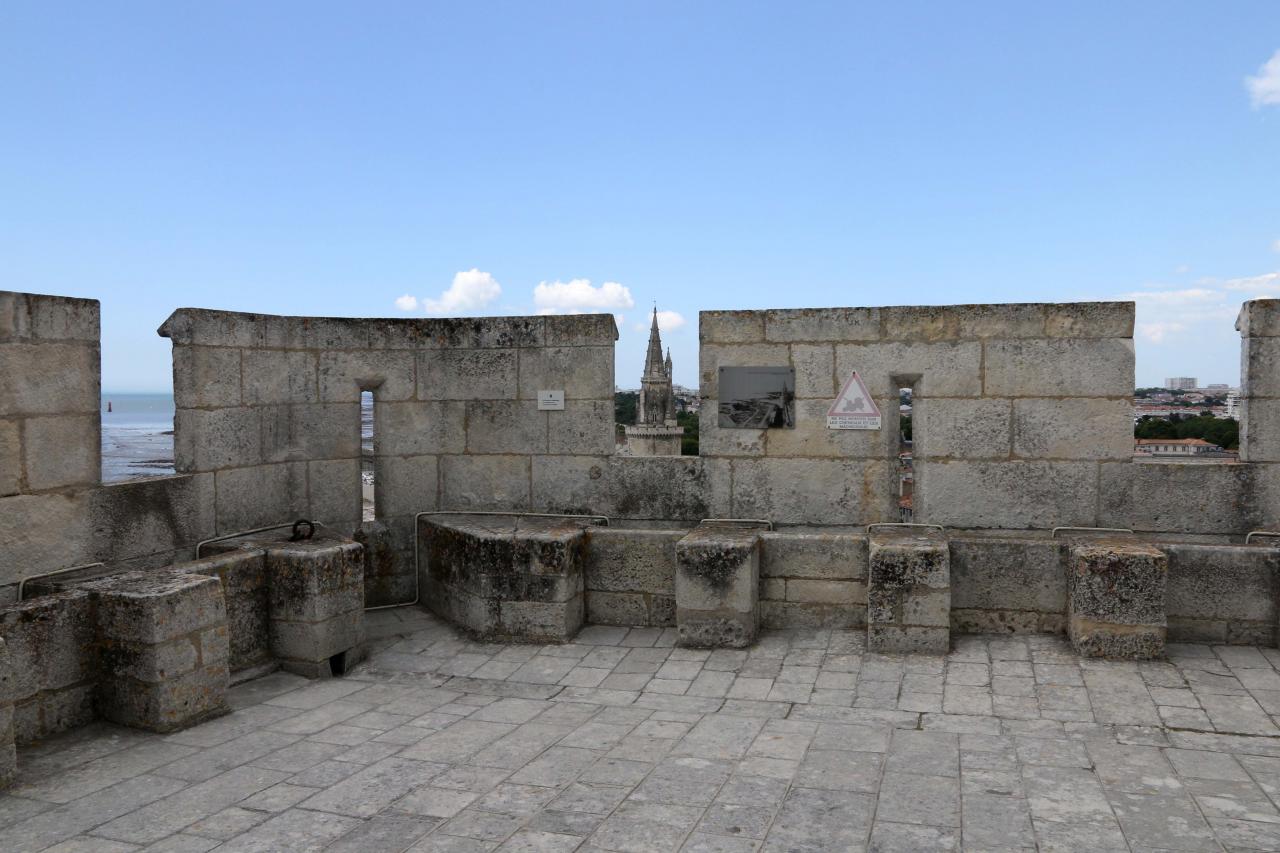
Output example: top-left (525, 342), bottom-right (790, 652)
top-left (584, 528), bottom-right (685, 596)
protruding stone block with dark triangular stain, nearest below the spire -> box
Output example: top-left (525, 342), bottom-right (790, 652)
top-left (676, 526), bottom-right (760, 648)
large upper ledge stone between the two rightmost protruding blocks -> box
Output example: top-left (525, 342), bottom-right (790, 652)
top-left (950, 537), bottom-right (1066, 613)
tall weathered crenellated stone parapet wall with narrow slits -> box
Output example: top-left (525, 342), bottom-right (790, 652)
top-left (0, 292), bottom-right (1280, 601)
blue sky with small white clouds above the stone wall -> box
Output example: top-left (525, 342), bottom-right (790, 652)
top-left (0, 0), bottom-right (1280, 391)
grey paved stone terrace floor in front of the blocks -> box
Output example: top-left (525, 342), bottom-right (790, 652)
top-left (0, 610), bottom-right (1280, 853)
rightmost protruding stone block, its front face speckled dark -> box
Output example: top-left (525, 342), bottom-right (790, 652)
top-left (1066, 540), bottom-right (1169, 660)
